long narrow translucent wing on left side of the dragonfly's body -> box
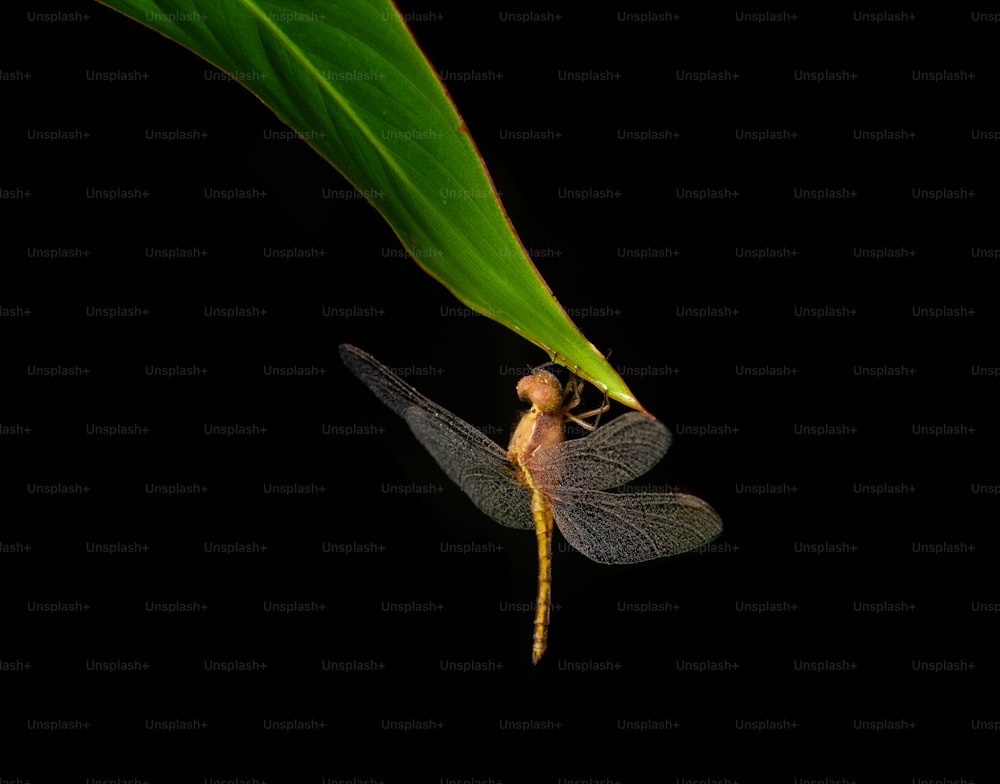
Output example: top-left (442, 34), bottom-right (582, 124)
top-left (340, 344), bottom-right (534, 529)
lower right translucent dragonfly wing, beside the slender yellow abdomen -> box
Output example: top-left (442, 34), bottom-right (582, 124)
top-left (545, 488), bottom-right (722, 564)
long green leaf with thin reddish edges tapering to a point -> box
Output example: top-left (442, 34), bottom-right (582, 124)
top-left (99, 0), bottom-right (642, 410)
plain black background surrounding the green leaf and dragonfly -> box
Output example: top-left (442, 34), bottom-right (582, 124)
top-left (0, 3), bottom-right (1000, 783)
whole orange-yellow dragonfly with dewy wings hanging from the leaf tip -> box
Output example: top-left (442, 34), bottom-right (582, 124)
top-left (340, 343), bottom-right (722, 664)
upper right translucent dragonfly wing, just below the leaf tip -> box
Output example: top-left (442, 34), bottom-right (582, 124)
top-left (532, 411), bottom-right (671, 490)
